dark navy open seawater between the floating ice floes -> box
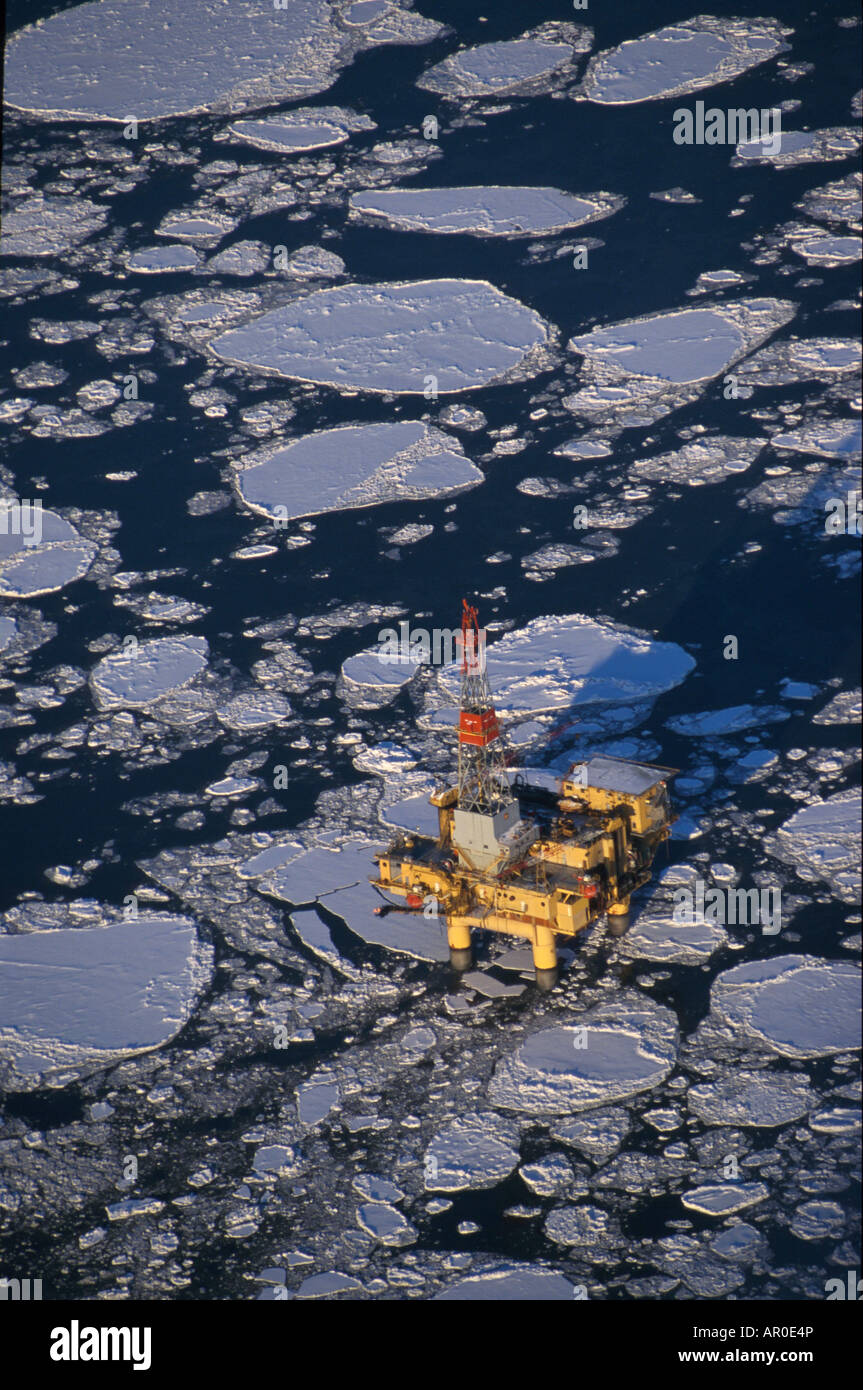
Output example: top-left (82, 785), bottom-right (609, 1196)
top-left (0, 0), bottom-right (860, 1298)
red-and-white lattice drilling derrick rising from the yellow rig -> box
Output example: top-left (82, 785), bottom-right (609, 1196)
top-left (459, 599), bottom-right (511, 816)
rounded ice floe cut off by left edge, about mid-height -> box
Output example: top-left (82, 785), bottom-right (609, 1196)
top-left (0, 500), bottom-right (96, 599)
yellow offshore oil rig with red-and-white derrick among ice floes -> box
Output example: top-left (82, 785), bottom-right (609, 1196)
top-left (371, 599), bottom-right (677, 990)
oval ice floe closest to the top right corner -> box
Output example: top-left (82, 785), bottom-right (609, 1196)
top-left (580, 14), bottom-right (791, 106)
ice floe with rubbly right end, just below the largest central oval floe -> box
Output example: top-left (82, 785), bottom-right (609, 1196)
top-left (235, 420), bottom-right (482, 521)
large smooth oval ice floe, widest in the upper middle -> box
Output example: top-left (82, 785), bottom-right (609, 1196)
top-left (210, 279), bottom-right (550, 395)
